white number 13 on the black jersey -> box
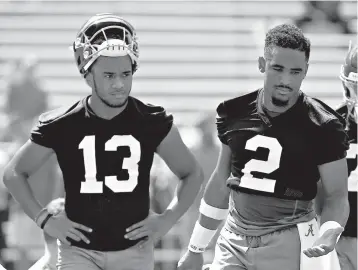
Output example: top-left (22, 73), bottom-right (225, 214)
top-left (79, 135), bottom-right (141, 193)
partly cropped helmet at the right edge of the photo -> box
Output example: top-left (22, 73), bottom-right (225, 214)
top-left (339, 41), bottom-right (358, 106)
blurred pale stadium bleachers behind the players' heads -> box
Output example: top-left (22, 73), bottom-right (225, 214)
top-left (0, 1), bottom-right (357, 126)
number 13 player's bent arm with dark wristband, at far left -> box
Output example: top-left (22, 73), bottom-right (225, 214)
top-left (4, 140), bottom-right (91, 244)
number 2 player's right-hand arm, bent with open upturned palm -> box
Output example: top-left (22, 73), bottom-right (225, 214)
top-left (304, 158), bottom-right (349, 257)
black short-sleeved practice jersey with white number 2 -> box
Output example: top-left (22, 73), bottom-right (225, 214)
top-left (217, 89), bottom-right (348, 200)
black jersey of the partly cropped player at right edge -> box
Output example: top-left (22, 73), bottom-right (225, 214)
top-left (337, 105), bottom-right (358, 237)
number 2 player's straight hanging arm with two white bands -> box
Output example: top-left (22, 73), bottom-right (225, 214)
top-left (178, 144), bottom-right (231, 270)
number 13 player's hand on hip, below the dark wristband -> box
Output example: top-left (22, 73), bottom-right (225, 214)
top-left (44, 212), bottom-right (92, 245)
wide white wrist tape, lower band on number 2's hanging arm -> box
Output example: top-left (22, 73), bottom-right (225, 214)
top-left (188, 221), bottom-right (216, 253)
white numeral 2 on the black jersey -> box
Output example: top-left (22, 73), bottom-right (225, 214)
top-left (240, 135), bottom-right (282, 193)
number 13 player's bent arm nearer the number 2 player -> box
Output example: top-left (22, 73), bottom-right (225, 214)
top-left (125, 125), bottom-right (203, 241)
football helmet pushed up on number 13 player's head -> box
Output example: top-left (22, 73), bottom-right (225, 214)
top-left (72, 13), bottom-right (139, 76)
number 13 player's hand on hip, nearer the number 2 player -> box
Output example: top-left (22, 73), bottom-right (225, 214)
top-left (124, 211), bottom-right (173, 244)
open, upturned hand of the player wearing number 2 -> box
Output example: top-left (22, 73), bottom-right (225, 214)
top-left (303, 227), bottom-right (344, 258)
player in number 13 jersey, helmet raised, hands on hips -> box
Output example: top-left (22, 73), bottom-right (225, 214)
top-left (4, 13), bottom-right (203, 270)
